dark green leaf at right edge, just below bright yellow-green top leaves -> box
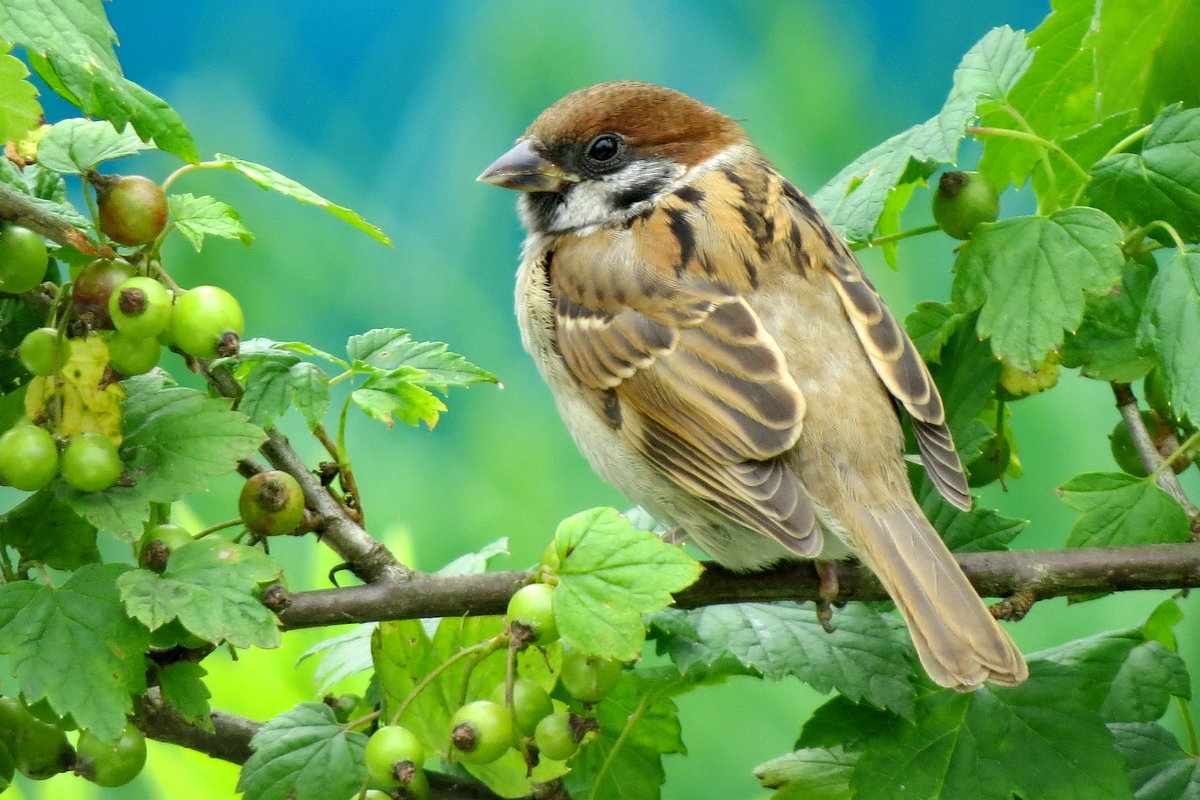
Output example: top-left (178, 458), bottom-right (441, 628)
top-left (1087, 106), bottom-right (1200, 241)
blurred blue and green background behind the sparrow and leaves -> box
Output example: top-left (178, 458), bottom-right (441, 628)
top-left (0, 0), bottom-right (1200, 800)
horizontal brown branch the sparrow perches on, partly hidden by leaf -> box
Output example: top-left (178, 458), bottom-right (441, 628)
top-left (280, 543), bottom-right (1200, 628)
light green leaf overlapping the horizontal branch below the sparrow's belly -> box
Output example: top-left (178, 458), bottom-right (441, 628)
top-left (553, 509), bottom-right (701, 661)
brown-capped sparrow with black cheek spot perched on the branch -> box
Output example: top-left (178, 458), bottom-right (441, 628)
top-left (479, 80), bottom-right (1028, 691)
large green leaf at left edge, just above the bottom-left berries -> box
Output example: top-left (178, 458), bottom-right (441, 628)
top-left (0, 564), bottom-right (150, 740)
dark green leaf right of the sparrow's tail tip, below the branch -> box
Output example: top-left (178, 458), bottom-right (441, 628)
top-left (1038, 628), bottom-right (1192, 722)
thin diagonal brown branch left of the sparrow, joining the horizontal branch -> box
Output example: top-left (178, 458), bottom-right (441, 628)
top-left (200, 365), bottom-right (412, 583)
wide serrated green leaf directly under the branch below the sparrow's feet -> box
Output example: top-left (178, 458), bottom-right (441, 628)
top-left (653, 603), bottom-right (916, 717)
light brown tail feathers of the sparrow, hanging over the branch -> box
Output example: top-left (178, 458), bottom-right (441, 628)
top-left (851, 506), bottom-right (1030, 691)
